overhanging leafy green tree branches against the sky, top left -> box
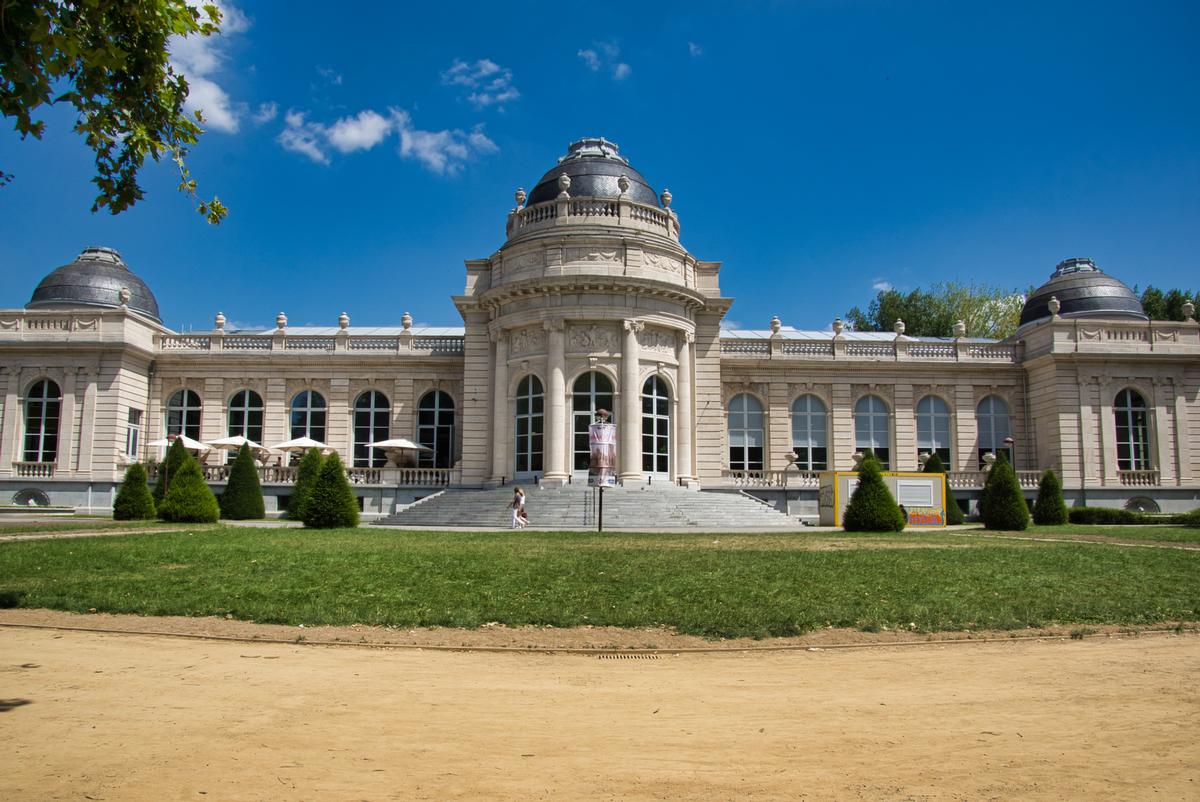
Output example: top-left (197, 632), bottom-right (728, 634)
top-left (0, 0), bottom-right (228, 223)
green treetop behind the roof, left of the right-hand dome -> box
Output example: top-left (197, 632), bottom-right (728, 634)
top-left (846, 281), bottom-right (1025, 340)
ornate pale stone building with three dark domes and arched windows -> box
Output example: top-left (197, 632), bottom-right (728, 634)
top-left (0, 139), bottom-right (1200, 515)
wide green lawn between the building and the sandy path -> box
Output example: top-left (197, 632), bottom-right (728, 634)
top-left (0, 527), bottom-right (1200, 636)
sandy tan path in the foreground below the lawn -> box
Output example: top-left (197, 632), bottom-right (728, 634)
top-left (0, 629), bottom-right (1200, 801)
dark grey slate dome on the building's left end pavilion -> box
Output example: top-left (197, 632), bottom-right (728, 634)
top-left (25, 247), bottom-right (162, 323)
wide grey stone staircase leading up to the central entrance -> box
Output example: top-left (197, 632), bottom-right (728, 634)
top-left (376, 484), bottom-right (800, 529)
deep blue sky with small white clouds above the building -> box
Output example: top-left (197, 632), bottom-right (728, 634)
top-left (0, 0), bottom-right (1200, 329)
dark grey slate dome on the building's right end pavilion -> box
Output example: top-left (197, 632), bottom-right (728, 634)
top-left (1020, 258), bottom-right (1150, 325)
